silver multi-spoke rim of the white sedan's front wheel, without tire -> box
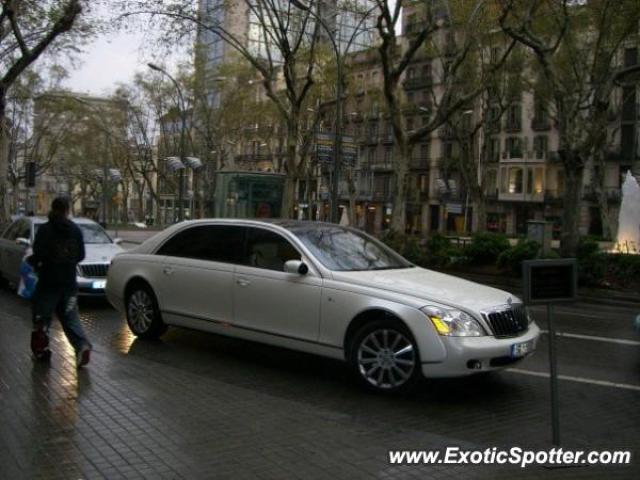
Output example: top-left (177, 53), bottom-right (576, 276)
top-left (358, 328), bottom-right (416, 389)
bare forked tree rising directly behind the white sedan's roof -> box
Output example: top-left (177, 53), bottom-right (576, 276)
top-left (119, 0), bottom-right (336, 216)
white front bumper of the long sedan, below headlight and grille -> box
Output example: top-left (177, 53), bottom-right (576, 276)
top-left (422, 322), bottom-right (540, 378)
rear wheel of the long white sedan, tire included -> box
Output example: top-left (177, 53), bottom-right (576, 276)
top-left (125, 282), bottom-right (167, 338)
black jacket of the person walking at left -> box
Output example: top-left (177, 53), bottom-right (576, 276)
top-left (30, 215), bottom-right (85, 288)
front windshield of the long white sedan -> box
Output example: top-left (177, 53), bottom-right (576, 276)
top-left (292, 226), bottom-right (413, 272)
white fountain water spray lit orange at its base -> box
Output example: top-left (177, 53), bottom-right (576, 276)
top-left (615, 171), bottom-right (640, 254)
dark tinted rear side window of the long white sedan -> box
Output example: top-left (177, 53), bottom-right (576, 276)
top-left (156, 225), bottom-right (244, 263)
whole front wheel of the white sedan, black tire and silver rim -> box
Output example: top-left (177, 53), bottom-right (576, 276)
top-left (349, 319), bottom-right (422, 394)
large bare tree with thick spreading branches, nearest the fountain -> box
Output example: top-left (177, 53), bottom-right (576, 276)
top-left (500, 0), bottom-right (640, 256)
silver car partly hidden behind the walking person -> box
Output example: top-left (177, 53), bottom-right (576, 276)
top-left (0, 217), bottom-right (124, 296)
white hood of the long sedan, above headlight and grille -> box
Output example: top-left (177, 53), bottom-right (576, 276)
top-left (333, 267), bottom-right (520, 312)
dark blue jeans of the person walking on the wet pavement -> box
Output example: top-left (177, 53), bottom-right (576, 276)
top-left (32, 287), bottom-right (91, 353)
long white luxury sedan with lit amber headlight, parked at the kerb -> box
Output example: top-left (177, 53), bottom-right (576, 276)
top-left (106, 219), bottom-right (540, 391)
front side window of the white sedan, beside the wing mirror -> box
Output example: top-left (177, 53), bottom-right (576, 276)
top-left (244, 228), bottom-right (301, 272)
